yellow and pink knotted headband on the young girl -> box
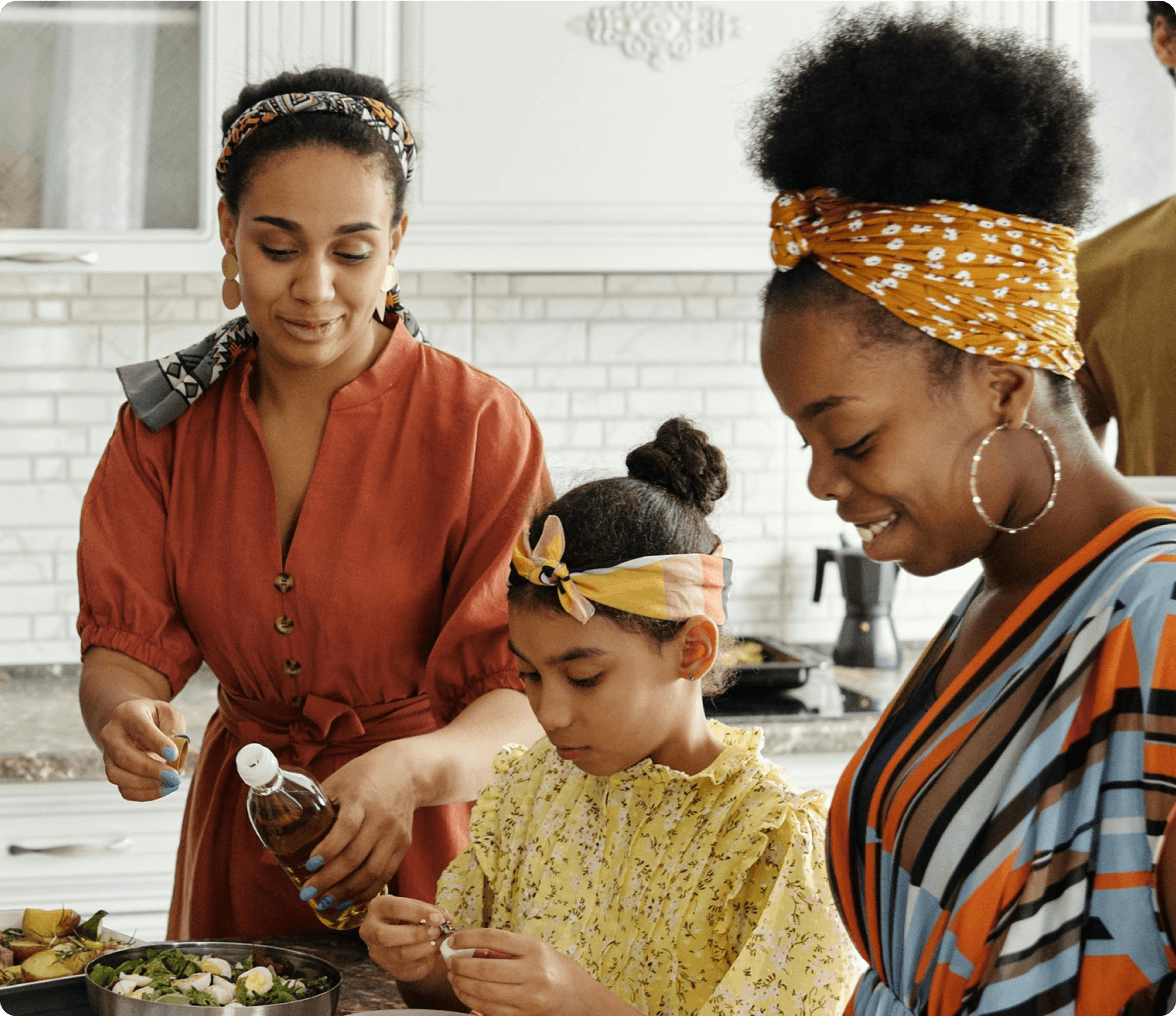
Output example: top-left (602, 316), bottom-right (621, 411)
top-left (512, 515), bottom-right (731, 624)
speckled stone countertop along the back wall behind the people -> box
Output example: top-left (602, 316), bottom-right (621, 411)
top-left (0, 646), bottom-right (921, 782)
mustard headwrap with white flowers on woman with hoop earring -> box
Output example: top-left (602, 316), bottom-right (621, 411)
top-left (771, 187), bottom-right (1083, 379)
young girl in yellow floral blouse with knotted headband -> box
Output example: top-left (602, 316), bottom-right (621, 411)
top-left (361, 420), bottom-right (853, 1016)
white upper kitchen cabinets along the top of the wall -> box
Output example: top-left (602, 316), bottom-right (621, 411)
top-left (0, 0), bottom-right (1089, 272)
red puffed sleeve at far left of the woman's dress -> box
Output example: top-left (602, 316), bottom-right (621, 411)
top-left (78, 405), bottom-right (201, 691)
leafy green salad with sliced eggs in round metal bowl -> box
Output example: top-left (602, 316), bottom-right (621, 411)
top-left (89, 949), bottom-right (330, 1009)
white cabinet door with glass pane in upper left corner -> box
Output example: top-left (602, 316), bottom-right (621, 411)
top-left (0, 0), bottom-right (245, 272)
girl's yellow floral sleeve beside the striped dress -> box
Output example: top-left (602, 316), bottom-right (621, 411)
top-left (697, 795), bottom-right (862, 1016)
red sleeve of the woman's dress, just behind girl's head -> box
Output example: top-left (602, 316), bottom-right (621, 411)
top-left (425, 382), bottom-right (552, 723)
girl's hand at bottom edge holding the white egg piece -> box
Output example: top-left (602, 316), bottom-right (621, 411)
top-left (449, 928), bottom-right (637, 1016)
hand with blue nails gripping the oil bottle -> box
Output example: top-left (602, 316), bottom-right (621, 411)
top-left (302, 742), bottom-right (417, 910)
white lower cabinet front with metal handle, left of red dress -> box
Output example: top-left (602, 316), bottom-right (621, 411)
top-left (0, 780), bottom-right (189, 941)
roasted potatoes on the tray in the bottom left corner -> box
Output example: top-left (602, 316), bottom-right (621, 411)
top-left (0, 907), bottom-right (127, 987)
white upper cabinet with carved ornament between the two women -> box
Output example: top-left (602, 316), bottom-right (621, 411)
top-left (356, 0), bottom-right (1085, 272)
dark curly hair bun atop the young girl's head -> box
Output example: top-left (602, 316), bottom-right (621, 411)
top-left (624, 416), bottom-right (727, 515)
